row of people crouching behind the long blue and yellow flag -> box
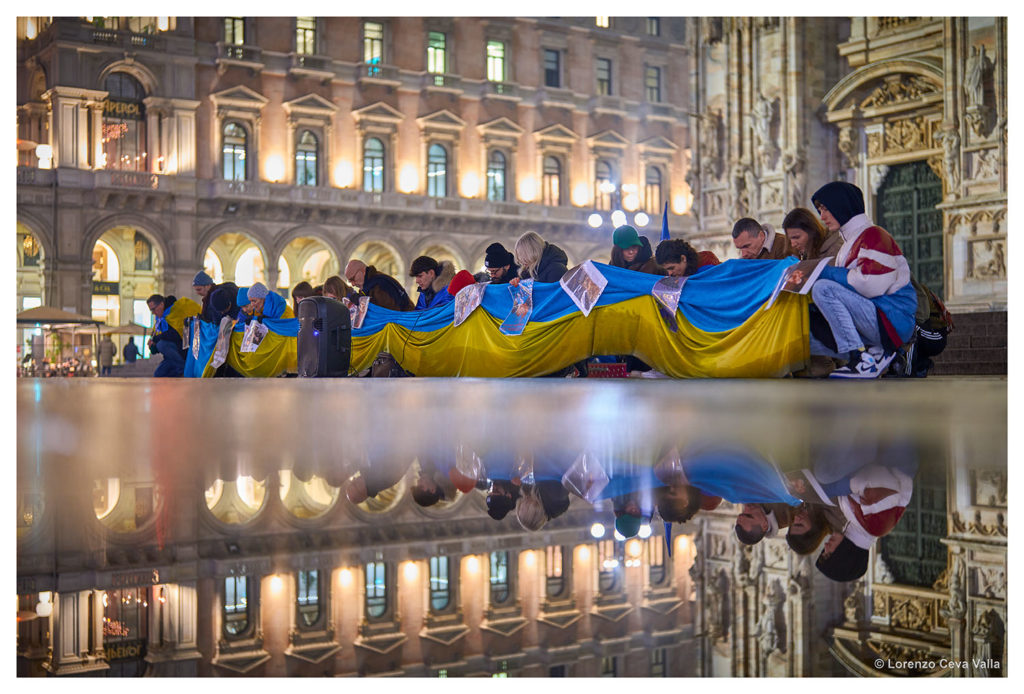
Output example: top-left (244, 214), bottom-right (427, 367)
top-left (140, 181), bottom-right (951, 379)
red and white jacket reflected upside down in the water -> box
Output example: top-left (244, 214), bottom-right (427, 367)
top-left (837, 465), bottom-right (913, 550)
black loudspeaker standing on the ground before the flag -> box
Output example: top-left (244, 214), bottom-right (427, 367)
top-left (297, 297), bottom-right (352, 379)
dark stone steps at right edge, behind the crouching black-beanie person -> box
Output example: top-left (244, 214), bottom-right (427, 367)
top-left (929, 311), bottom-right (1007, 376)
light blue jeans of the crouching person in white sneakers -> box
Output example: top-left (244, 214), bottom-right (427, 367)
top-left (811, 279), bottom-right (882, 359)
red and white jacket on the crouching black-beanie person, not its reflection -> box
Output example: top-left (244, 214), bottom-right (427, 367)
top-left (836, 214), bottom-right (910, 299)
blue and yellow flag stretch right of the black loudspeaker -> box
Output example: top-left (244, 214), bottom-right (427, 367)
top-left (351, 259), bottom-right (809, 378)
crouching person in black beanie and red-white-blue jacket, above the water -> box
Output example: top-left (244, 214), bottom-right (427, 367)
top-left (810, 181), bottom-right (918, 379)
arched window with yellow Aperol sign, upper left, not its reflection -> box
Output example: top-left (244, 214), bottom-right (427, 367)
top-left (98, 73), bottom-right (148, 171)
